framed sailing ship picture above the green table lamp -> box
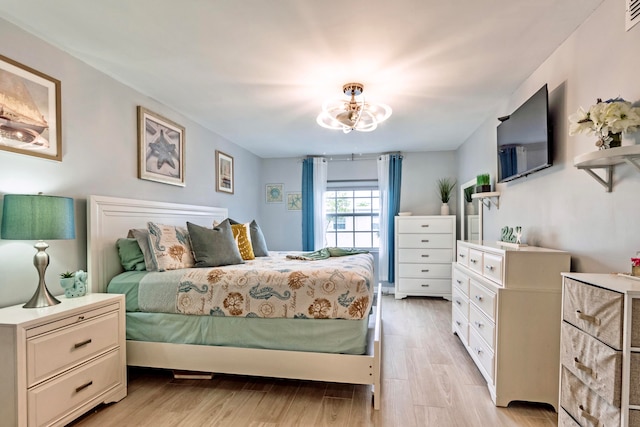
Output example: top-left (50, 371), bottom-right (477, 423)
top-left (0, 55), bottom-right (62, 162)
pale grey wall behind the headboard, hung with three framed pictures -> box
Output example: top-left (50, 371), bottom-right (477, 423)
top-left (0, 19), bottom-right (262, 307)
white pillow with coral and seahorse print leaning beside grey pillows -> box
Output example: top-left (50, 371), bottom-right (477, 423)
top-left (147, 222), bottom-right (195, 271)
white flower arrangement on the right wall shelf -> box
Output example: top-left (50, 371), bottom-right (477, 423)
top-left (569, 98), bottom-right (640, 149)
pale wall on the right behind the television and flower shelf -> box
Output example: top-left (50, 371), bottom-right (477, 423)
top-left (458, 0), bottom-right (640, 273)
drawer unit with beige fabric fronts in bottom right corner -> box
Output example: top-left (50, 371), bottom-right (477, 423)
top-left (558, 273), bottom-right (640, 426)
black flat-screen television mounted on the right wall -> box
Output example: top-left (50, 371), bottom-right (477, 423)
top-left (497, 84), bottom-right (553, 182)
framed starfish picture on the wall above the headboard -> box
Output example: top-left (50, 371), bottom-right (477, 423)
top-left (138, 106), bottom-right (186, 187)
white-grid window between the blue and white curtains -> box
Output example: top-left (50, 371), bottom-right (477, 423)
top-left (325, 183), bottom-right (380, 248)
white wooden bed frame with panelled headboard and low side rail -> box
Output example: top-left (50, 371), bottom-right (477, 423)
top-left (87, 196), bottom-right (382, 409)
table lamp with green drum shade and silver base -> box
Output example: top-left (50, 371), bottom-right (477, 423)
top-left (0, 194), bottom-right (76, 308)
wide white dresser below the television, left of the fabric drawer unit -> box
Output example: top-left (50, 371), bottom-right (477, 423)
top-left (451, 241), bottom-right (571, 409)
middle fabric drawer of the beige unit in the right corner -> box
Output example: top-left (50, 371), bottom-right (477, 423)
top-left (560, 322), bottom-right (622, 406)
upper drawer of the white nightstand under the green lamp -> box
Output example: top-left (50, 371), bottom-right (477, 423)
top-left (27, 312), bottom-right (120, 387)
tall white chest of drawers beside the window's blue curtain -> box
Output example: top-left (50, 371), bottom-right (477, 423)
top-left (395, 215), bottom-right (456, 299)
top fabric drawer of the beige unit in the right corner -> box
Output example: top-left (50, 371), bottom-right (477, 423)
top-left (562, 277), bottom-right (623, 350)
